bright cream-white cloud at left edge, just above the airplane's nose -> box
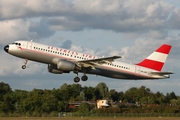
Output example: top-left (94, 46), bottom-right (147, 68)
top-left (0, 19), bottom-right (55, 45)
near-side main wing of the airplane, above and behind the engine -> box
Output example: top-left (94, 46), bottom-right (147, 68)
top-left (76, 56), bottom-right (121, 69)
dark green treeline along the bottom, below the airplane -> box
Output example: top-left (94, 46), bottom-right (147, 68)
top-left (0, 82), bottom-right (180, 116)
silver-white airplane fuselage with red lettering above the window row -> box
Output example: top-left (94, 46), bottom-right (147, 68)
top-left (4, 41), bottom-right (169, 80)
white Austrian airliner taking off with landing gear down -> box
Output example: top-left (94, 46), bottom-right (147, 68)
top-left (4, 40), bottom-right (173, 82)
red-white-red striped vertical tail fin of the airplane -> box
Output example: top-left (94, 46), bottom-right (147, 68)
top-left (136, 44), bottom-right (172, 71)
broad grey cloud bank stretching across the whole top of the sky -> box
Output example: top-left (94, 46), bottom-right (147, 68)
top-left (0, 0), bottom-right (180, 33)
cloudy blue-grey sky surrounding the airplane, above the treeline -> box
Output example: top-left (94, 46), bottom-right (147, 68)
top-left (0, 0), bottom-right (180, 95)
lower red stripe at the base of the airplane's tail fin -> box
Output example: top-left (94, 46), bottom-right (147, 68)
top-left (137, 59), bottom-right (164, 71)
